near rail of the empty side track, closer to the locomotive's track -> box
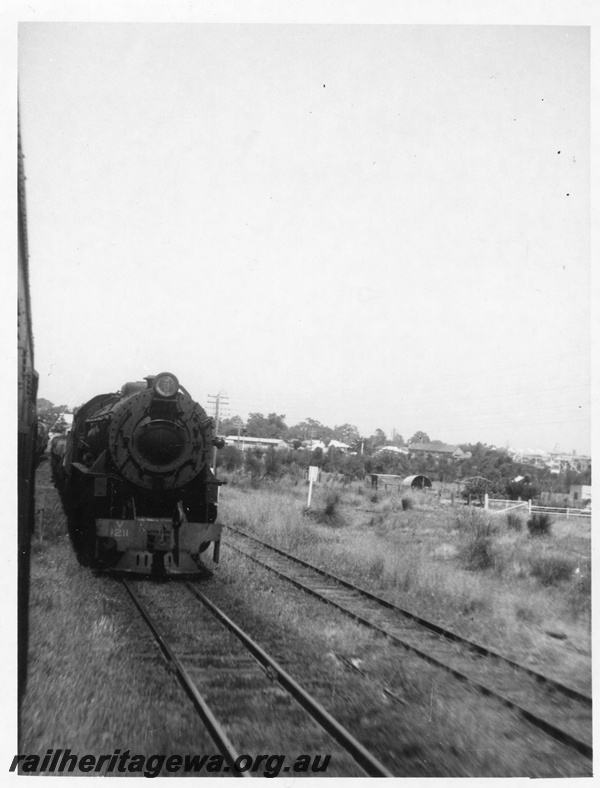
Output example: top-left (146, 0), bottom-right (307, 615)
top-left (229, 532), bottom-right (593, 760)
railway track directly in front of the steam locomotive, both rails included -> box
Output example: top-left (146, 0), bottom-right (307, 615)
top-left (122, 580), bottom-right (393, 777)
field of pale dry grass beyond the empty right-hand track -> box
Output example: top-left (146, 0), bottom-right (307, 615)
top-left (221, 470), bottom-right (591, 691)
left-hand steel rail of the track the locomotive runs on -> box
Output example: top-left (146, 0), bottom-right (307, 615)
top-left (121, 579), bottom-right (251, 777)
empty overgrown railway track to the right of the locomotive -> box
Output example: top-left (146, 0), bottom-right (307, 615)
top-left (226, 526), bottom-right (593, 760)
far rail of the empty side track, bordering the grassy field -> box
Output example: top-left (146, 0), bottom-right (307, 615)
top-left (227, 526), bottom-right (592, 708)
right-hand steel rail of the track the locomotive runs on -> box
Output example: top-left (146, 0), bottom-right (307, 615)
top-left (186, 581), bottom-right (394, 777)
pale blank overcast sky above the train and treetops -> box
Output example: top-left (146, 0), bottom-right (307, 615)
top-left (19, 18), bottom-right (591, 453)
